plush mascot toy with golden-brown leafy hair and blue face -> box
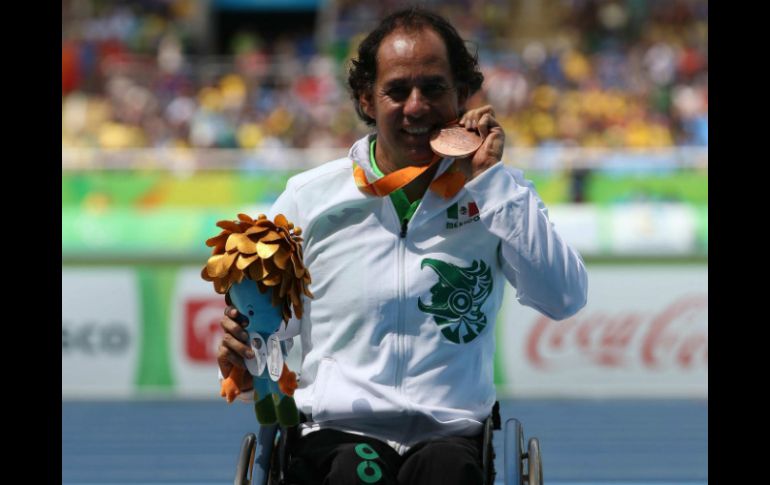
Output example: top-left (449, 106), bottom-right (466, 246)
top-left (201, 214), bottom-right (313, 426)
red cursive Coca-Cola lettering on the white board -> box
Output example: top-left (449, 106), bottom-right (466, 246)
top-left (526, 295), bottom-right (708, 370)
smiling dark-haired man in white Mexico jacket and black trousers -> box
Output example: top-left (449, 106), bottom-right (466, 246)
top-left (218, 8), bottom-right (587, 485)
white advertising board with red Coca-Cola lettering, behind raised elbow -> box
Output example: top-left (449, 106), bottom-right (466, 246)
top-left (497, 265), bottom-right (708, 398)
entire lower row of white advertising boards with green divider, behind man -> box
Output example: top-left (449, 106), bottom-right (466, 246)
top-left (62, 264), bottom-right (708, 399)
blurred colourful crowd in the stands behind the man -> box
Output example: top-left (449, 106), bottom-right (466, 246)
top-left (62, 0), bottom-right (708, 149)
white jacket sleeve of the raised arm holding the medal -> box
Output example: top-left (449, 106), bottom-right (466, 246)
top-left (465, 162), bottom-right (588, 320)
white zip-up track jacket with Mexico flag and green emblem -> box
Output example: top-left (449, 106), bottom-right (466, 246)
top-left (270, 135), bottom-right (587, 453)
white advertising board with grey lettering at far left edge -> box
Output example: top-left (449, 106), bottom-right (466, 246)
top-left (62, 268), bottom-right (141, 398)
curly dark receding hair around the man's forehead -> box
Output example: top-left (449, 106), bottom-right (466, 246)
top-left (348, 7), bottom-right (484, 126)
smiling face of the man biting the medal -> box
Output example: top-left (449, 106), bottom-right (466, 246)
top-left (359, 28), bottom-right (466, 170)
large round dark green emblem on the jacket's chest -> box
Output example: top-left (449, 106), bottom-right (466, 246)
top-left (417, 258), bottom-right (492, 344)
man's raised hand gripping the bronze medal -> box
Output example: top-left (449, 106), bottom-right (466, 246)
top-left (460, 105), bottom-right (505, 180)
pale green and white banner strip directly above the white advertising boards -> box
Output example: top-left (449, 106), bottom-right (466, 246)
top-left (62, 203), bottom-right (708, 264)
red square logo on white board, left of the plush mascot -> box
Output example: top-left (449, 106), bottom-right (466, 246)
top-left (184, 297), bottom-right (225, 363)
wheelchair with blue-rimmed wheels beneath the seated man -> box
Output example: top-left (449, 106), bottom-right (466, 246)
top-left (234, 403), bottom-right (543, 485)
